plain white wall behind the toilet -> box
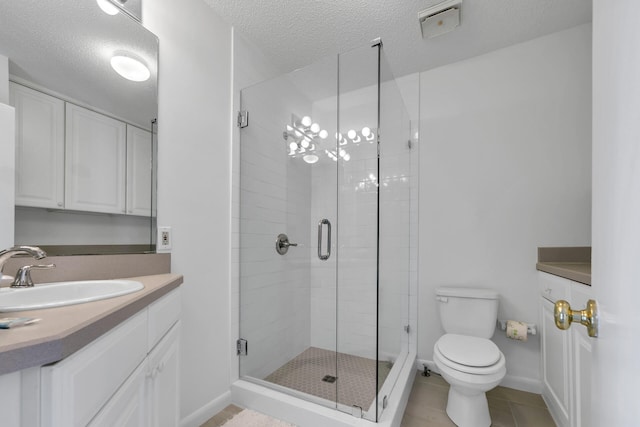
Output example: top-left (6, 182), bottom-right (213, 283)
top-left (418, 25), bottom-right (591, 390)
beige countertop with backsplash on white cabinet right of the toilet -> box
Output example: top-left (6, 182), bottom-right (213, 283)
top-left (536, 246), bottom-right (591, 286)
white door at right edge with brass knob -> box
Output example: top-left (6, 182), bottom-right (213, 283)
top-left (592, 0), bottom-right (640, 427)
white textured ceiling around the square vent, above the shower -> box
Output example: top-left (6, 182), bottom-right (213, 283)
top-left (203, 0), bottom-right (592, 76)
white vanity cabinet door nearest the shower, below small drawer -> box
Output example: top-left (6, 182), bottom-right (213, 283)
top-left (148, 321), bottom-right (180, 427)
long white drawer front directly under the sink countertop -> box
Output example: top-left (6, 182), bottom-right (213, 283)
top-left (42, 310), bottom-right (147, 427)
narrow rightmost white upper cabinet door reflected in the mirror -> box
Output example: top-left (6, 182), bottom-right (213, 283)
top-left (127, 125), bottom-right (152, 216)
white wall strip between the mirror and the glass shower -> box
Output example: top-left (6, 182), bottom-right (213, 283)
top-left (143, 0), bottom-right (232, 425)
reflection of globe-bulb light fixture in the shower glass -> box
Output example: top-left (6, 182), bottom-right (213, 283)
top-left (282, 114), bottom-right (375, 164)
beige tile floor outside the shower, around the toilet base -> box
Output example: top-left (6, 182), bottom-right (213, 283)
top-left (201, 372), bottom-right (555, 427)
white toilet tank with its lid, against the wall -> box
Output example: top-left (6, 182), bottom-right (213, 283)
top-left (436, 287), bottom-right (500, 338)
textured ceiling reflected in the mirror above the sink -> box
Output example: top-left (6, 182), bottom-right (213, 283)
top-left (0, 0), bottom-right (158, 127)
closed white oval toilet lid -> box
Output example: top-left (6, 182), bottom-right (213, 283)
top-left (437, 334), bottom-right (500, 368)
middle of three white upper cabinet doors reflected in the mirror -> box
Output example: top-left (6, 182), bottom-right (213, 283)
top-left (65, 103), bottom-right (127, 214)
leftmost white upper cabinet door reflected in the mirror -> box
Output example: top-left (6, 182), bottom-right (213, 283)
top-left (9, 82), bottom-right (64, 209)
